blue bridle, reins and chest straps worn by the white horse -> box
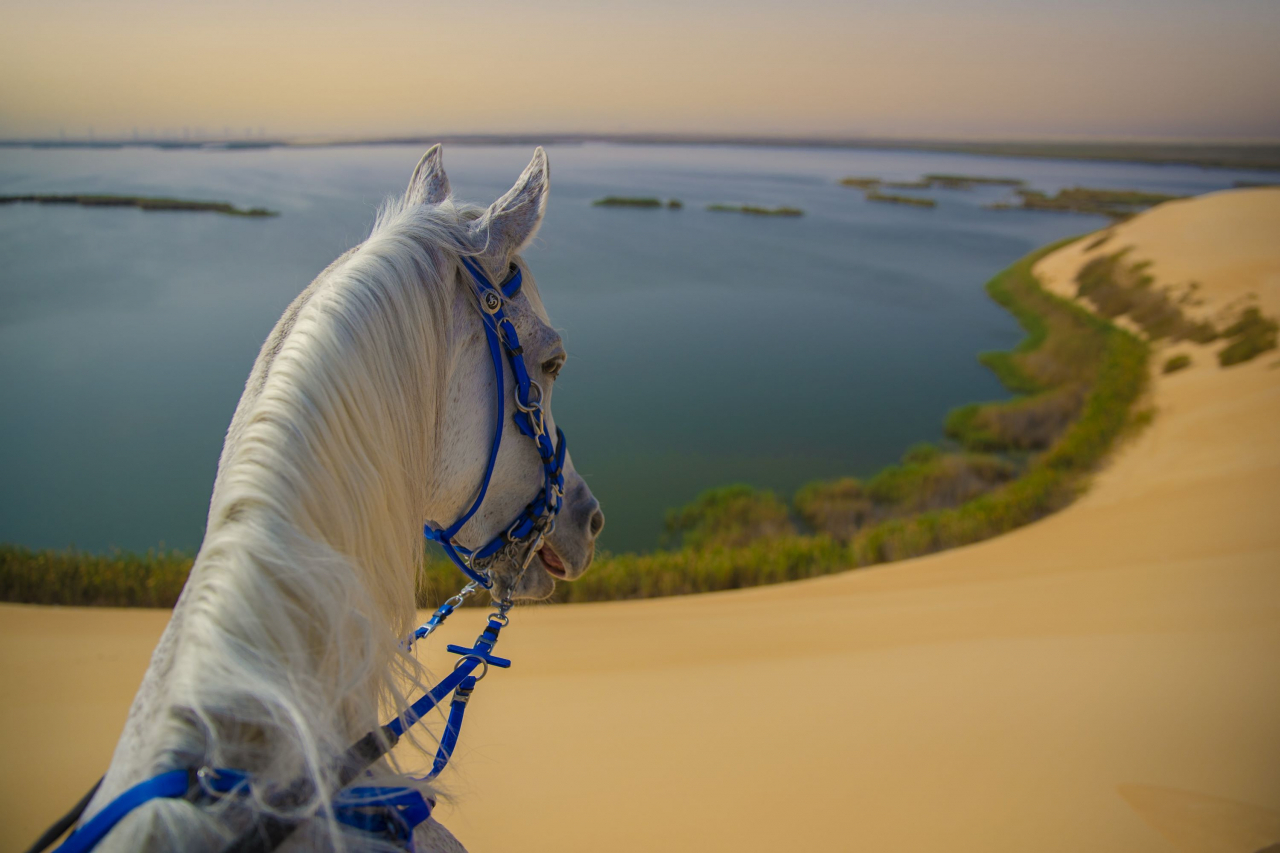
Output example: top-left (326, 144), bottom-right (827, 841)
top-left (36, 257), bottom-right (566, 853)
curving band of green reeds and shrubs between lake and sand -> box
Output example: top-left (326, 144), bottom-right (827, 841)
top-left (0, 241), bottom-right (1157, 607)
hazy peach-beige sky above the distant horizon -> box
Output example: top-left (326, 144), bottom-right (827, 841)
top-left (0, 0), bottom-right (1280, 138)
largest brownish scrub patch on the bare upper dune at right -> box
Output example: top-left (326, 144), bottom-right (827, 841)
top-left (1075, 250), bottom-right (1217, 343)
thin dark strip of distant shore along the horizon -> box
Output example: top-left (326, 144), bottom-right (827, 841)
top-left (0, 133), bottom-right (1280, 172)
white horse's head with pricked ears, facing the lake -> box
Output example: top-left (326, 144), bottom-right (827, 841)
top-left (406, 146), bottom-right (604, 598)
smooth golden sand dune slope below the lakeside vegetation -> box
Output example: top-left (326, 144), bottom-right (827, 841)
top-left (0, 192), bottom-right (1280, 853)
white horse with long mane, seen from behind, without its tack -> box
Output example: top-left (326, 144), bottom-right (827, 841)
top-left (82, 146), bottom-right (604, 852)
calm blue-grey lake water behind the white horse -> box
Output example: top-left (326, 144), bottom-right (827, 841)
top-left (0, 145), bottom-right (1263, 551)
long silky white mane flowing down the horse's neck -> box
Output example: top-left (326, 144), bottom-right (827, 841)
top-left (136, 190), bottom-right (483, 848)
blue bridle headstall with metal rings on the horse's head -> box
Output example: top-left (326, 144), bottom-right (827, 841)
top-left (422, 257), bottom-right (566, 589)
